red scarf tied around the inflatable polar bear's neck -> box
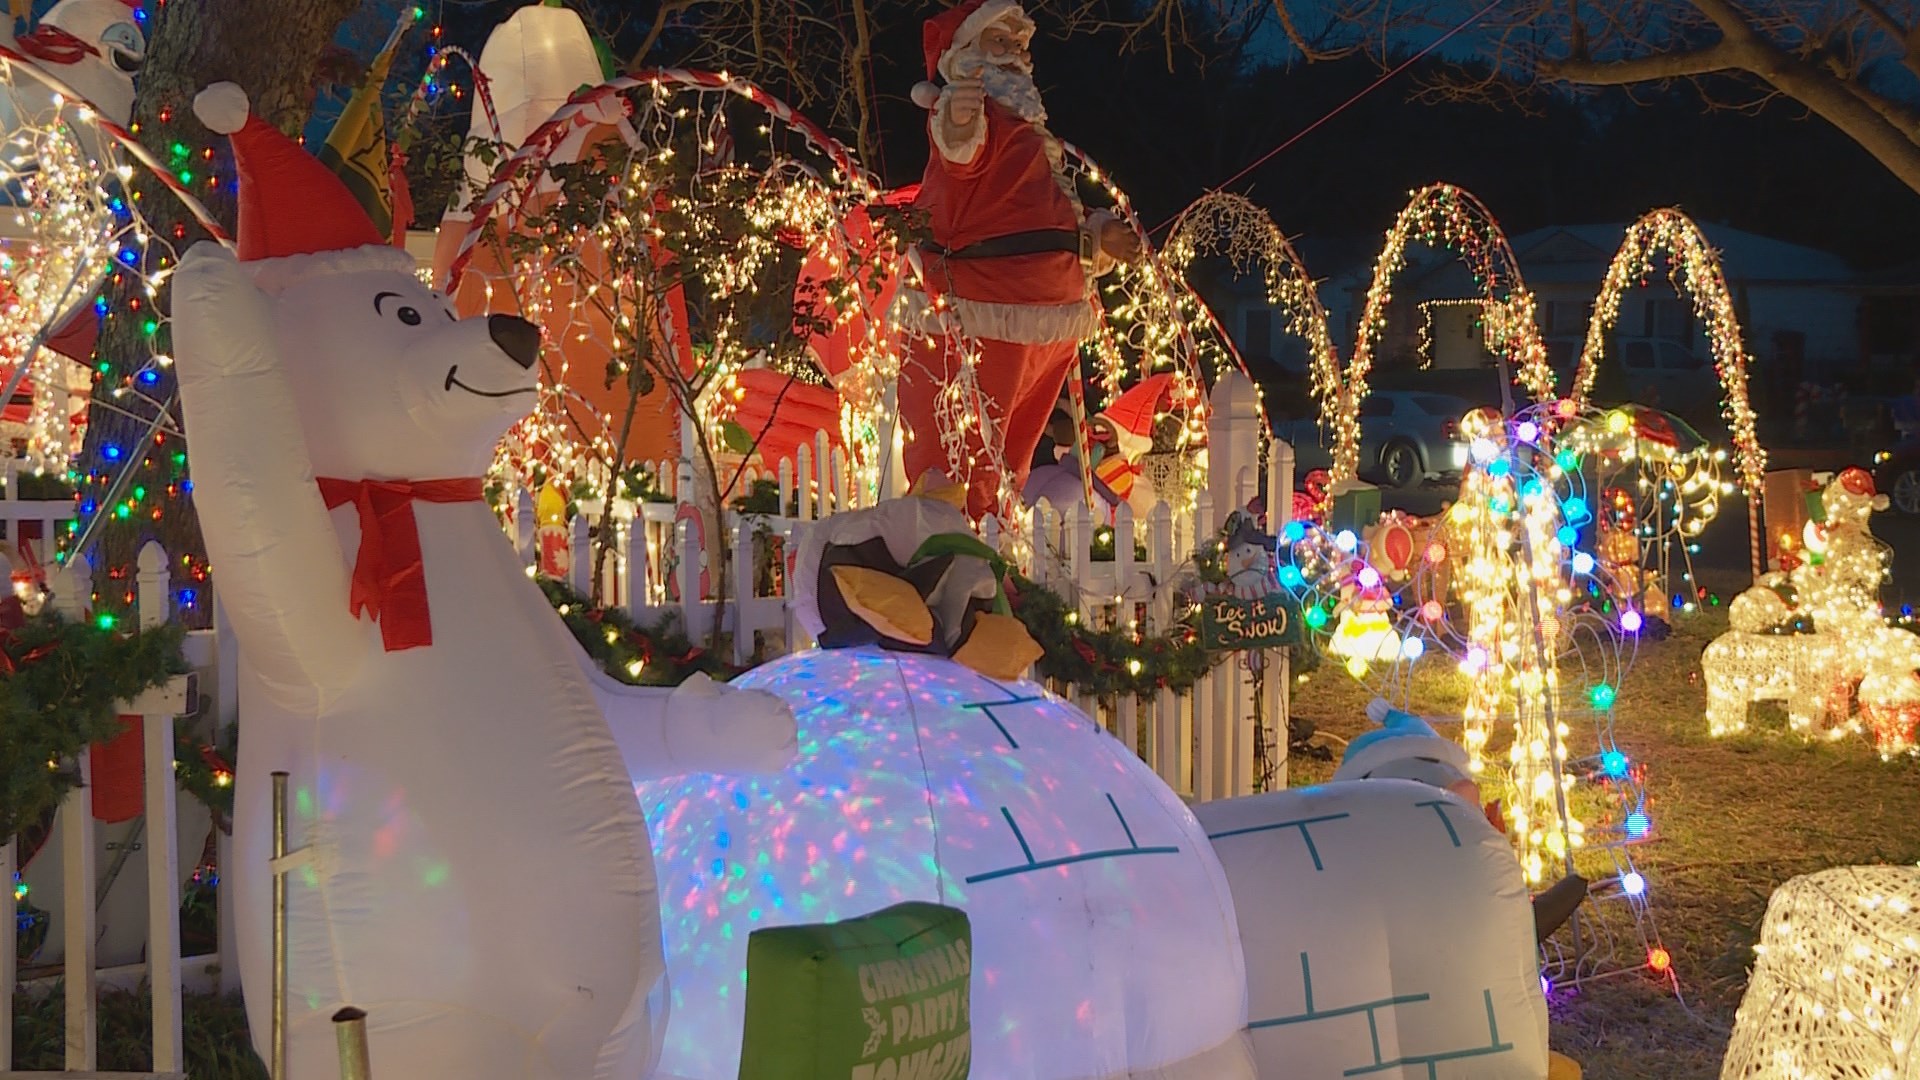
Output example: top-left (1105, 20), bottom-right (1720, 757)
top-left (319, 477), bottom-right (486, 653)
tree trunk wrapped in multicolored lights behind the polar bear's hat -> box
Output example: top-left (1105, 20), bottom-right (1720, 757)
top-left (77, 0), bottom-right (357, 621)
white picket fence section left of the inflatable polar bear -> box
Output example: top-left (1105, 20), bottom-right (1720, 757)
top-left (0, 544), bottom-right (197, 1080)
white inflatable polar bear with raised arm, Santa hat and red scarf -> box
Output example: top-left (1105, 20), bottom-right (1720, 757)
top-left (173, 85), bottom-right (793, 1080)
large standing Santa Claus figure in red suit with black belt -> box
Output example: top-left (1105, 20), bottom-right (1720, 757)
top-left (899, 0), bottom-right (1140, 517)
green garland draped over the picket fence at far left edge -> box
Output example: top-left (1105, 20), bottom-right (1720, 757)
top-left (0, 611), bottom-right (186, 836)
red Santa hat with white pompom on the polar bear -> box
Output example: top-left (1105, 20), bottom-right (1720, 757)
top-left (194, 83), bottom-right (417, 292)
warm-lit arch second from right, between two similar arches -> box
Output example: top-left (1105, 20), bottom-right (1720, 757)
top-left (1315, 184), bottom-right (1553, 482)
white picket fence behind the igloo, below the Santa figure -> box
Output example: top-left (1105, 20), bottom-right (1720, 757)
top-left (533, 375), bottom-right (1292, 799)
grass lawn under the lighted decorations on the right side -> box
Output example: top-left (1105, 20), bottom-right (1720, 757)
top-left (1290, 582), bottom-right (1920, 1080)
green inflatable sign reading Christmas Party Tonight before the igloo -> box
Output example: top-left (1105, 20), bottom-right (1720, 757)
top-left (739, 901), bottom-right (973, 1080)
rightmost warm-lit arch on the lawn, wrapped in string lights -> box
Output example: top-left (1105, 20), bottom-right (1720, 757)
top-left (1569, 208), bottom-right (1766, 577)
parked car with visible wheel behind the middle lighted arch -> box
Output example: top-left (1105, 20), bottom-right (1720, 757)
top-left (1275, 390), bottom-right (1473, 488)
